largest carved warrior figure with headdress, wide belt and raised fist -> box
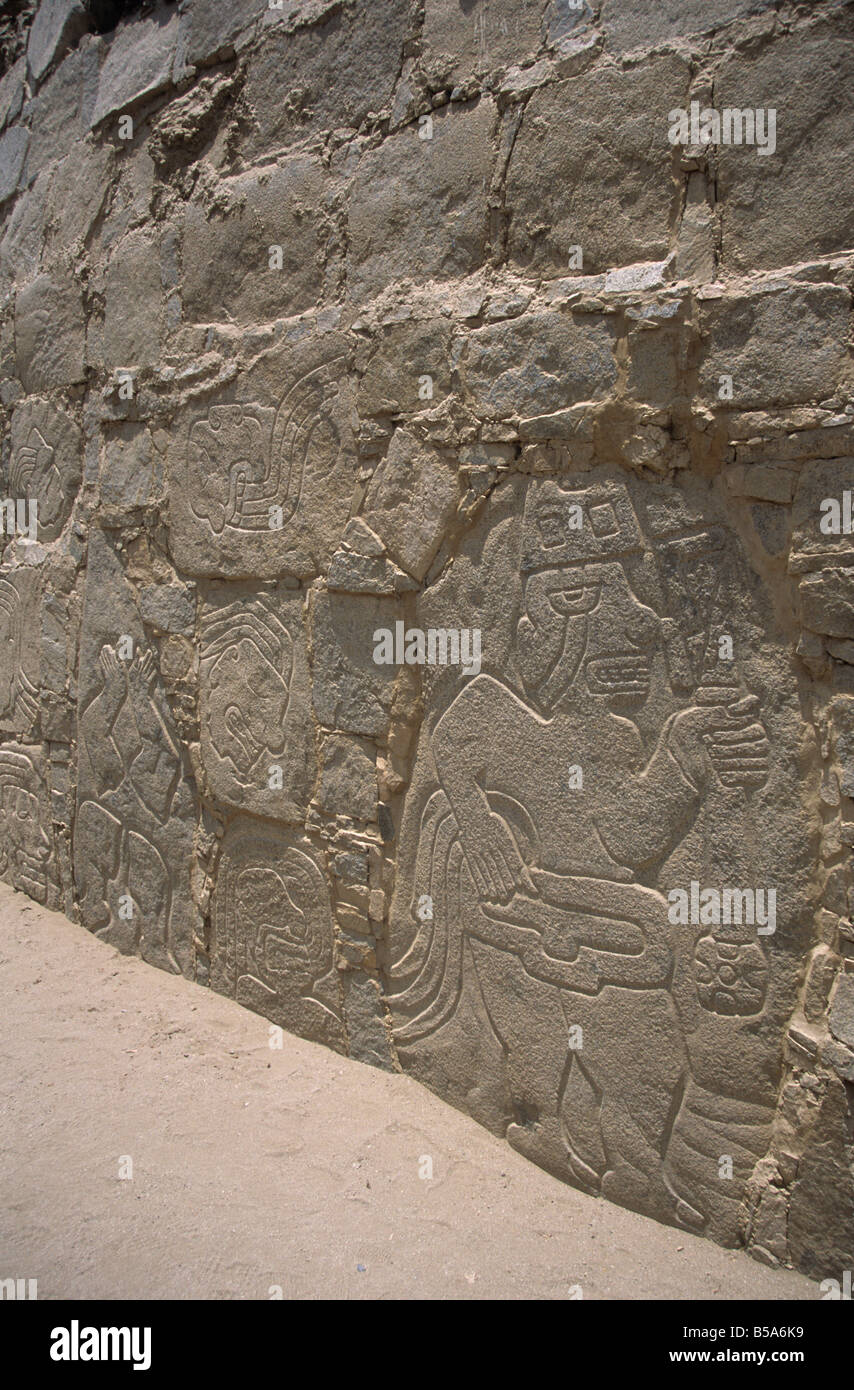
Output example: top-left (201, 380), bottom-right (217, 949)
top-left (389, 481), bottom-right (768, 1229)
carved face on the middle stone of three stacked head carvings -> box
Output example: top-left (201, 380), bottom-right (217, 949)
top-left (207, 638), bottom-right (289, 776)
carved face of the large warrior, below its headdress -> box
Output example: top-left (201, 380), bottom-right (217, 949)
top-left (519, 562), bottom-right (659, 709)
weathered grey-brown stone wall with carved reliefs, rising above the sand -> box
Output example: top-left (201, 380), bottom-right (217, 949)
top-left (0, 0), bottom-right (854, 1282)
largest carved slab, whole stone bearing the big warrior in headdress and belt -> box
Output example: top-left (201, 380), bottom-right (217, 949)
top-left (391, 473), bottom-right (814, 1244)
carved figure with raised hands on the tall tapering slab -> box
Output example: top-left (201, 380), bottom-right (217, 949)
top-left (75, 646), bottom-right (186, 972)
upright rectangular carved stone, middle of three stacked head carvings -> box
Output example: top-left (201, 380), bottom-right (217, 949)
top-left (200, 584), bottom-right (316, 823)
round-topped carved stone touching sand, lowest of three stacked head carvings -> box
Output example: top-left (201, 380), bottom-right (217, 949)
top-left (211, 817), bottom-right (345, 1051)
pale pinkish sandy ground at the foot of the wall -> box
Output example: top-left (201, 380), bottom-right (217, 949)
top-left (0, 885), bottom-right (819, 1300)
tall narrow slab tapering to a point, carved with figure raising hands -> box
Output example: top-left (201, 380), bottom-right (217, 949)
top-left (74, 531), bottom-right (200, 974)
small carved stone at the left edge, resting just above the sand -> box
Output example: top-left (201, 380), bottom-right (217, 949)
top-left (0, 746), bottom-right (50, 904)
